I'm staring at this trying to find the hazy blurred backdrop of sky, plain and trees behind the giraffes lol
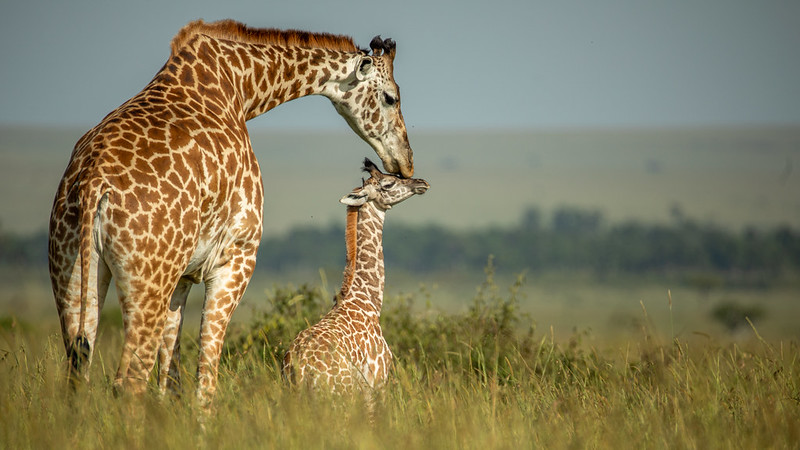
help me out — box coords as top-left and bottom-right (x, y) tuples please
(0, 0), (800, 339)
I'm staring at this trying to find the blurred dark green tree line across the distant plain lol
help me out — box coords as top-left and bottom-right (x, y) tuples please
(0, 207), (800, 275)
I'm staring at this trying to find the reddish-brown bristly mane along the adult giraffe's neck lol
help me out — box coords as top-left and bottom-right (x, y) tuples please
(171, 19), (363, 54)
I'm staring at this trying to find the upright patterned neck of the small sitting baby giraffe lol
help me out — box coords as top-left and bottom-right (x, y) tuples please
(341, 203), (386, 315)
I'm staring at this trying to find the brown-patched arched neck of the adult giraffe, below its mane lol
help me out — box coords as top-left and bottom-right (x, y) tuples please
(167, 30), (357, 120)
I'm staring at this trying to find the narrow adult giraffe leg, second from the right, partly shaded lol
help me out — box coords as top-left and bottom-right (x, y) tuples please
(158, 278), (192, 395)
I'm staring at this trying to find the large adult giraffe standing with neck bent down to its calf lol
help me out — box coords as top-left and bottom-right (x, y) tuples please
(49, 20), (414, 405)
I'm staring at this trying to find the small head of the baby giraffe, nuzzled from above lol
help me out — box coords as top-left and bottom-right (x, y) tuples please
(339, 158), (431, 211)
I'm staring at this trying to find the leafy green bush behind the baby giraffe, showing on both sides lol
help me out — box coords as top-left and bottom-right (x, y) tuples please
(224, 257), (599, 385)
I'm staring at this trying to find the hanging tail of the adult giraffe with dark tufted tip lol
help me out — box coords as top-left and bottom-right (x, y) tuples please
(67, 178), (104, 373)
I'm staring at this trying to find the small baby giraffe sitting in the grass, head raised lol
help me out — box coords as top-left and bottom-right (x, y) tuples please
(283, 159), (430, 392)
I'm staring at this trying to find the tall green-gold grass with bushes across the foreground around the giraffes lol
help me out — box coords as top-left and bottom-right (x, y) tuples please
(0, 264), (800, 449)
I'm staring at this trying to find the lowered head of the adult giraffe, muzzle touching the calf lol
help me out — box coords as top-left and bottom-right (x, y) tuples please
(330, 36), (414, 178)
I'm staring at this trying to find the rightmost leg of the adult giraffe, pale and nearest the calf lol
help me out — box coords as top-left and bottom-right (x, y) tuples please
(197, 245), (258, 409)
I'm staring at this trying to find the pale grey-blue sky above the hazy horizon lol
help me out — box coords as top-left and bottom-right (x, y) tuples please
(0, 0), (800, 132)
